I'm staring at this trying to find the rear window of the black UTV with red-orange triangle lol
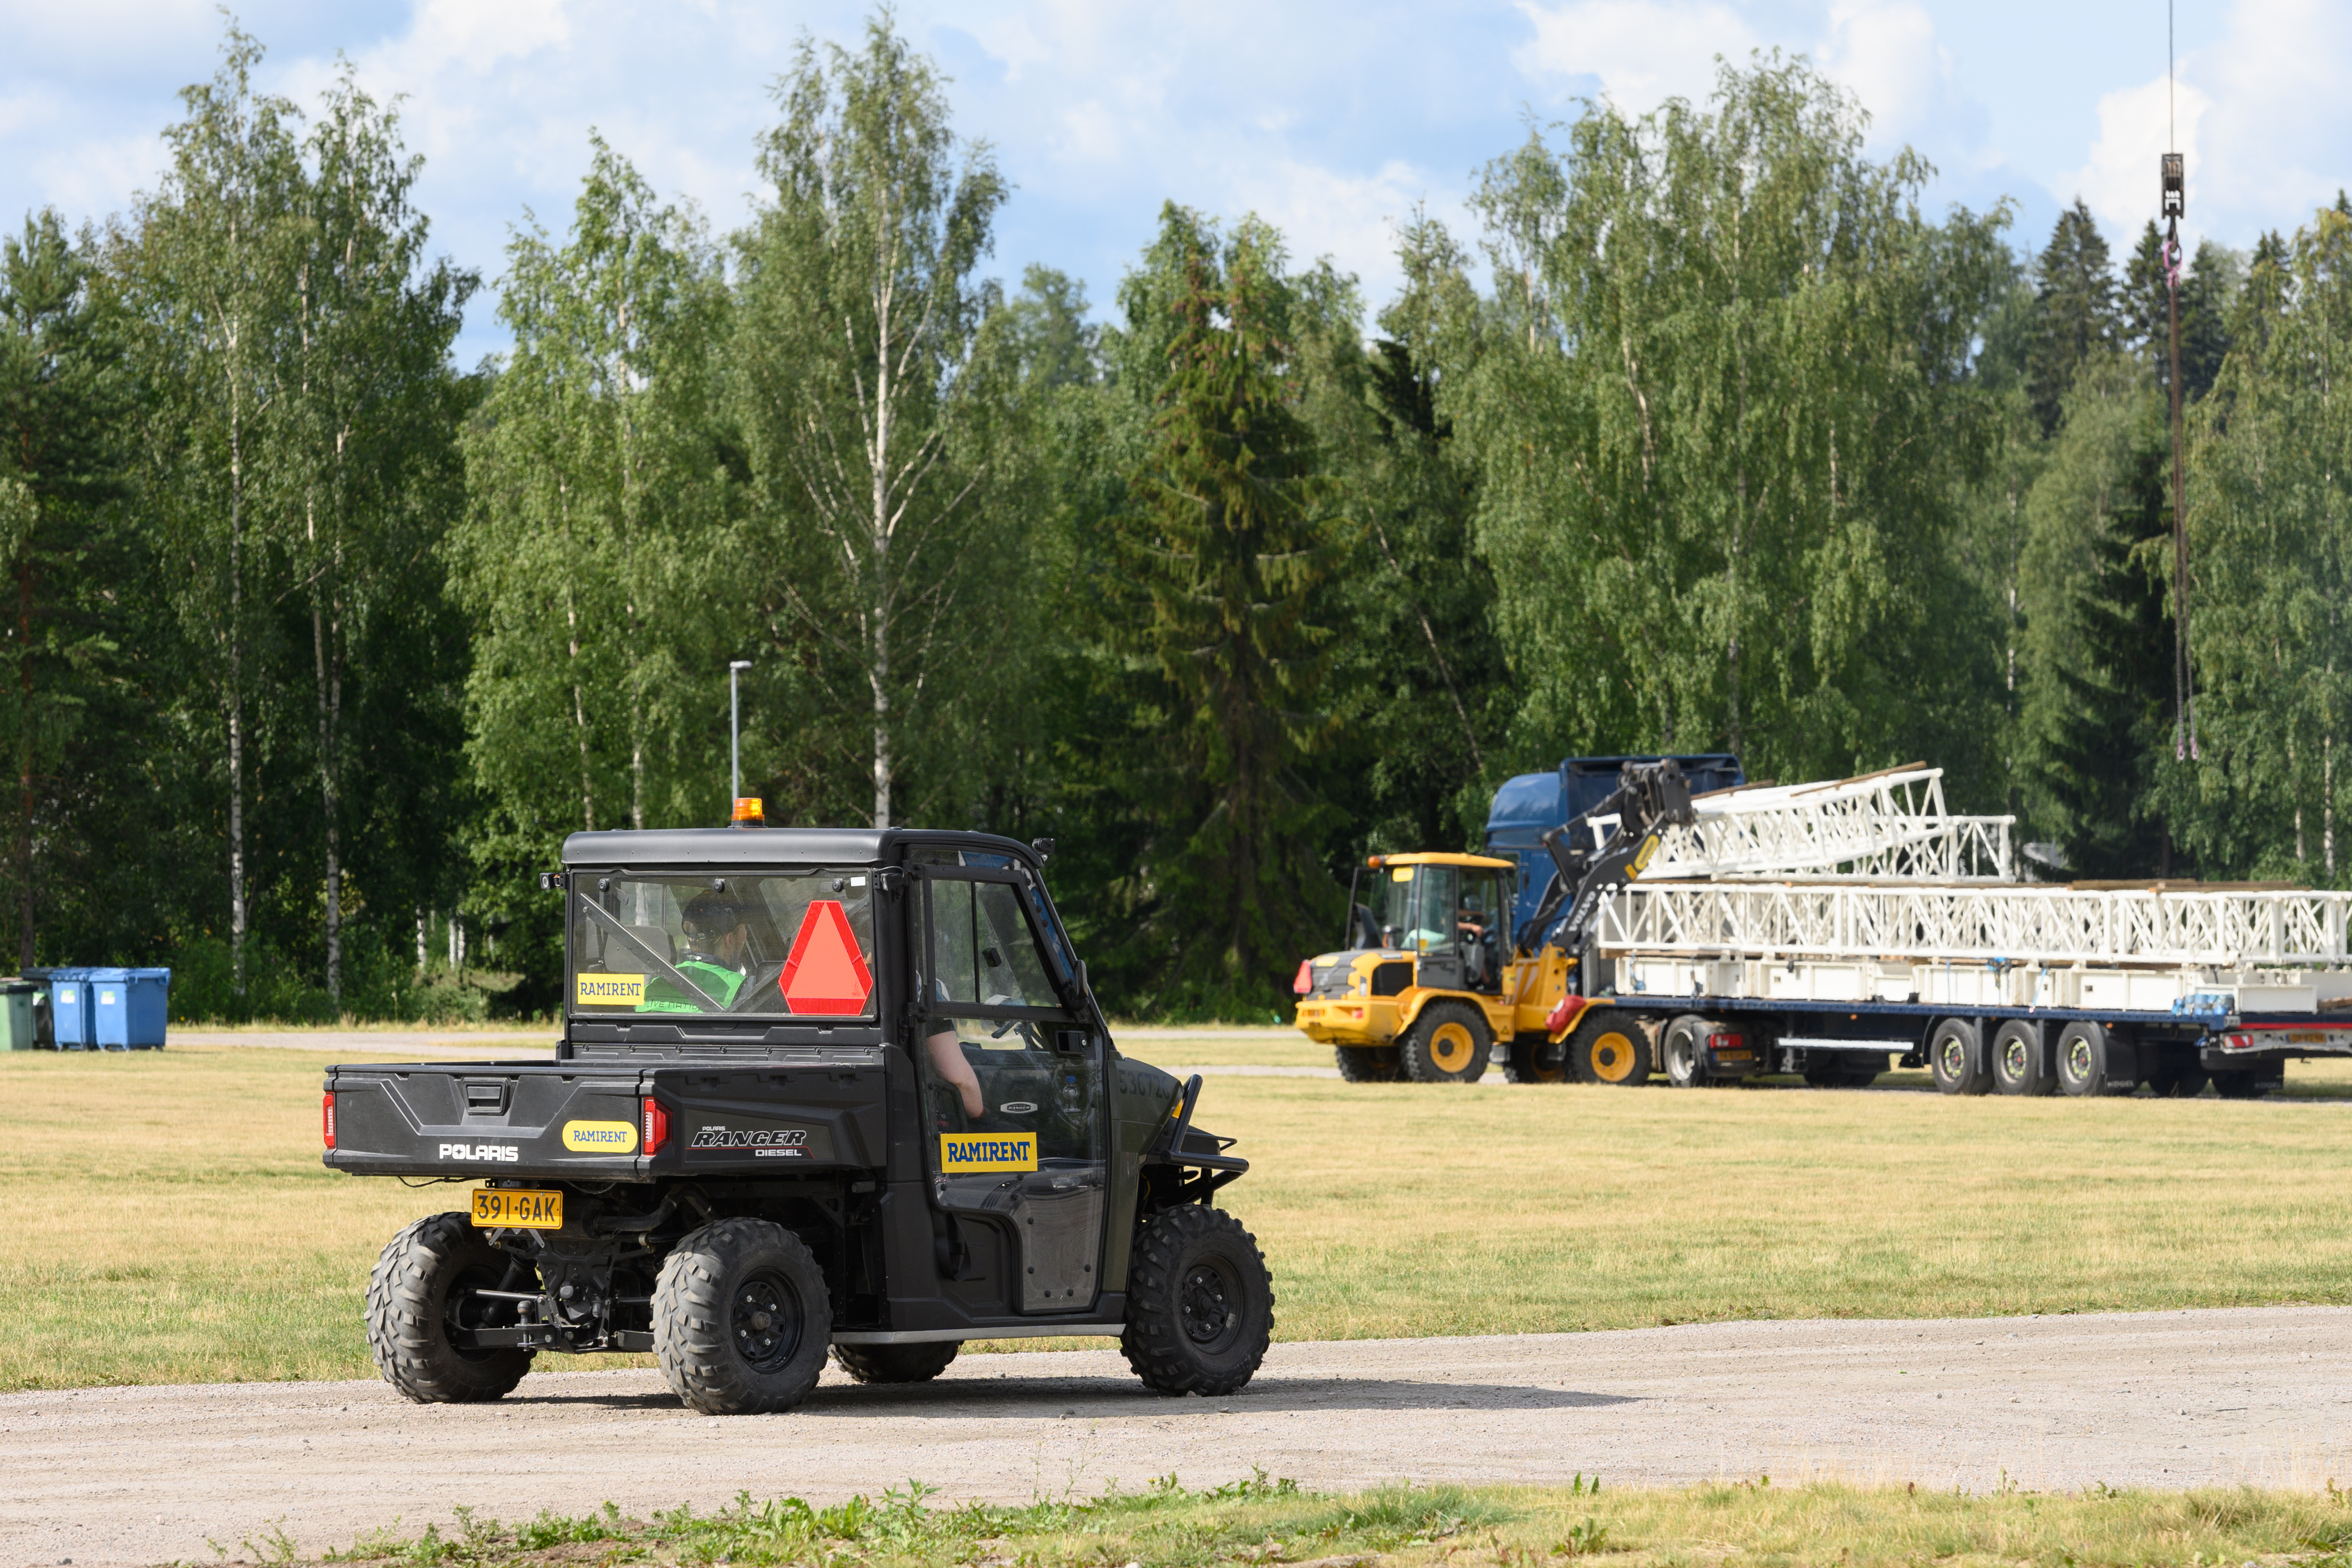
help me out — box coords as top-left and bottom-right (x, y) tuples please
(572, 868), (875, 1020)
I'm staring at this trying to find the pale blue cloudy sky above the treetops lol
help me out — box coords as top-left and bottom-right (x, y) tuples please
(0, 0), (2352, 362)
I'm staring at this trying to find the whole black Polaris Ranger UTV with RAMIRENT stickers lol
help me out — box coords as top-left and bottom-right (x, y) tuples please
(324, 827), (1272, 1415)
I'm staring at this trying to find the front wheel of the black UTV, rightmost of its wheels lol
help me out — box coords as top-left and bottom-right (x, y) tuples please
(1119, 1204), (1275, 1396)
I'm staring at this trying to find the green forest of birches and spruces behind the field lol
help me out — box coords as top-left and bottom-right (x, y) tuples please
(0, 14), (2352, 1020)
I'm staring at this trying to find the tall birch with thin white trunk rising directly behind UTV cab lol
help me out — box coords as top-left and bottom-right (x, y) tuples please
(734, 14), (1007, 827)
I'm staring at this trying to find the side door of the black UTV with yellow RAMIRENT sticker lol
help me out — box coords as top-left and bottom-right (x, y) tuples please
(913, 865), (1110, 1312)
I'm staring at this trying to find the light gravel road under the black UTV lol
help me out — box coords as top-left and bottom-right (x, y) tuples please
(0, 1307), (2352, 1568)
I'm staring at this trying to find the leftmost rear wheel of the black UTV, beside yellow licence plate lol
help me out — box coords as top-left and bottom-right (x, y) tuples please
(367, 1213), (536, 1406)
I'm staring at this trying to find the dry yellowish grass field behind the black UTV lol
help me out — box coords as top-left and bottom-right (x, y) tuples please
(0, 1037), (2352, 1389)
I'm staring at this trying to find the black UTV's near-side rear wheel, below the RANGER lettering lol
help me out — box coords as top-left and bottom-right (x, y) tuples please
(654, 1220), (833, 1415)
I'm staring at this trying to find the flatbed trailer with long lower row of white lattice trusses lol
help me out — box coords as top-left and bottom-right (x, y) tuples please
(1571, 882), (2352, 1098)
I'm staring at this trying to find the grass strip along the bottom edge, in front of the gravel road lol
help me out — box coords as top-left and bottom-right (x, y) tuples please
(298, 1472), (2352, 1568)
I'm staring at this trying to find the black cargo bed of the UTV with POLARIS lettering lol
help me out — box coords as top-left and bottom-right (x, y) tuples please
(324, 1051), (887, 1183)
